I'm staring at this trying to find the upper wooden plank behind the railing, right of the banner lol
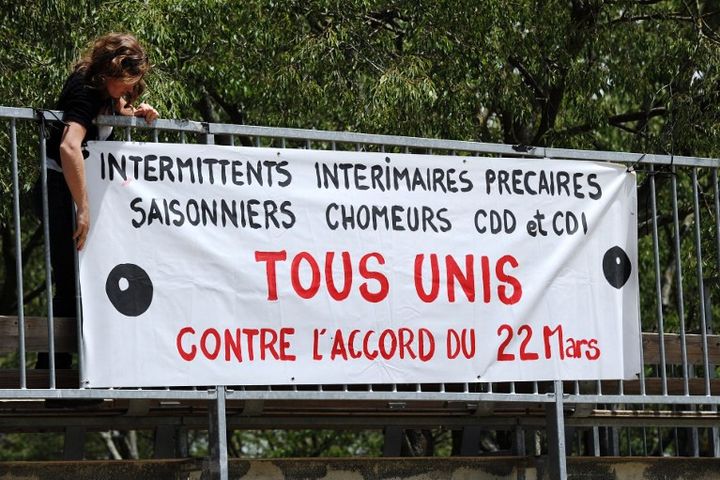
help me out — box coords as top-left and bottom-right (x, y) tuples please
(643, 333), (720, 365)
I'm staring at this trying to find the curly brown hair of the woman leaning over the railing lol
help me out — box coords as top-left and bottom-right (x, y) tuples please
(73, 33), (150, 103)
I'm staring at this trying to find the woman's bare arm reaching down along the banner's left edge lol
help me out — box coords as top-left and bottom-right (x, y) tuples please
(60, 121), (90, 250)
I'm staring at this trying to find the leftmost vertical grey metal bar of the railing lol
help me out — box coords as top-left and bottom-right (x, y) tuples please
(10, 118), (27, 389)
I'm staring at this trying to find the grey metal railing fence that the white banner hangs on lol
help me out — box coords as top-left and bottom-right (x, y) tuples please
(0, 107), (720, 478)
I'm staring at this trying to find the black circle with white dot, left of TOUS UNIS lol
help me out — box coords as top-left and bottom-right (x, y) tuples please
(105, 263), (153, 317)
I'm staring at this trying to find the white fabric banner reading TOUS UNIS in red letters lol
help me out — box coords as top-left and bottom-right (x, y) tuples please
(80, 142), (640, 387)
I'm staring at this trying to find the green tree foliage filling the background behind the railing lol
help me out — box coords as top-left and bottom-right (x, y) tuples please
(0, 0), (720, 460)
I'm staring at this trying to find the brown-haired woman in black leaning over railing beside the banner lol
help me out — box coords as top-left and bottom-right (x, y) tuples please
(36, 33), (158, 368)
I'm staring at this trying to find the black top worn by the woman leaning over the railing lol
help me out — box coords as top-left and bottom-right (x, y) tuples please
(47, 72), (112, 165)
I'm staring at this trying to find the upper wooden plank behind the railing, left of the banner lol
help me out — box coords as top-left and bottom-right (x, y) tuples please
(0, 316), (77, 354)
